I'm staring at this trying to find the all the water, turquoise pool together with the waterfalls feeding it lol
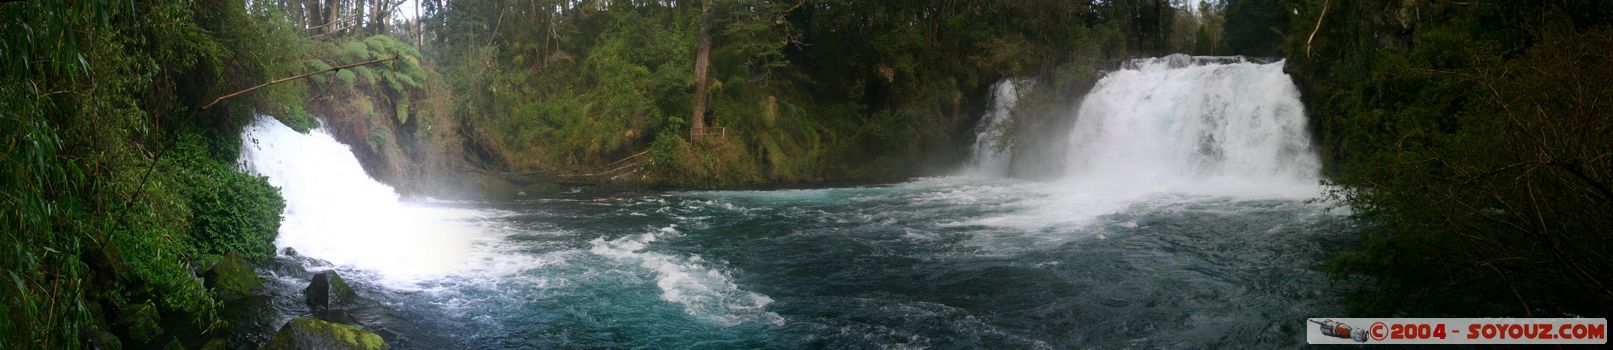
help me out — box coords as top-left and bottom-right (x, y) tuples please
(242, 56), (1353, 348)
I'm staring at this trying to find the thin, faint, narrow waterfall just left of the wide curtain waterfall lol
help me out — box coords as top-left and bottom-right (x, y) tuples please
(971, 79), (1019, 177)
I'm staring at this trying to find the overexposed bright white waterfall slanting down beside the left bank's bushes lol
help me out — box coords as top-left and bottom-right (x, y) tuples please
(240, 116), (471, 279)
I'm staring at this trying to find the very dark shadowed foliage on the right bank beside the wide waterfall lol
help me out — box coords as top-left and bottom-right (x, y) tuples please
(1283, 0), (1613, 316)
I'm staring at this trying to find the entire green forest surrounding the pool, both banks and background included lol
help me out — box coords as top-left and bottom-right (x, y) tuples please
(0, 0), (1613, 348)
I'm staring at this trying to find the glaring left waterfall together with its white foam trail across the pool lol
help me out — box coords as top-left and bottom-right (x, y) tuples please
(240, 116), (782, 326)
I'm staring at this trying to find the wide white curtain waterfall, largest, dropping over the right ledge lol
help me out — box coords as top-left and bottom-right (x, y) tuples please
(1066, 55), (1319, 195)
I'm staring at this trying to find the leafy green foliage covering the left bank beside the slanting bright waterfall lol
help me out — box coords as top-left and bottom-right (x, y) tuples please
(0, 0), (302, 348)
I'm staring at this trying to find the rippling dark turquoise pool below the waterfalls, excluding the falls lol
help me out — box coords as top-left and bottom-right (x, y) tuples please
(235, 177), (1355, 348)
